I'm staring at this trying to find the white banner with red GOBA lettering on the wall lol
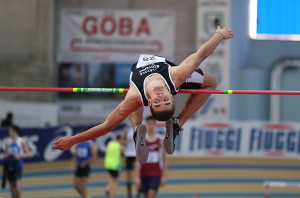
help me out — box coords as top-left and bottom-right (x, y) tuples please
(58, 9), (175, 62)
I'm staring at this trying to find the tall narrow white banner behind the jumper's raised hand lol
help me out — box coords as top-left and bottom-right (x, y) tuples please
(197, 0), (230, 120)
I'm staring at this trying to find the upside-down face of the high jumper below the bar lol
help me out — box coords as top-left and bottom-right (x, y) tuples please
(148, 89), (174, 111)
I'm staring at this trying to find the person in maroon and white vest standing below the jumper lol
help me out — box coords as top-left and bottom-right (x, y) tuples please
(135, 116), (168, 198)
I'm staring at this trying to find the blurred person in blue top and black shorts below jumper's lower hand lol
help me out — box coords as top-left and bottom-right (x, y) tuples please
(70, 130), (97, 198)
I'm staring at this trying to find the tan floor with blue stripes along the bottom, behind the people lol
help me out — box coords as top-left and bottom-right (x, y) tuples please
(0, 157), (300, 198)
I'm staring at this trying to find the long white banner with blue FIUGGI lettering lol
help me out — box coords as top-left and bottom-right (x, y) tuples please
(158, 122), (300, 158)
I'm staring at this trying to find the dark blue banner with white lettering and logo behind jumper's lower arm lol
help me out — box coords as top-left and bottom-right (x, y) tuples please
(0, 124), (125, 162)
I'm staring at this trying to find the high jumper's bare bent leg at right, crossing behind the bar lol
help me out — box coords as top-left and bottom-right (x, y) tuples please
(179, 70), (217, 126)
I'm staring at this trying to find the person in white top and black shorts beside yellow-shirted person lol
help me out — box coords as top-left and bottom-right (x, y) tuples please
(123, 126), (136, 198)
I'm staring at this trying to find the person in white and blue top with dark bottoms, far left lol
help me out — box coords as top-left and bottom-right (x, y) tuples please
(4, 125), (31, 198)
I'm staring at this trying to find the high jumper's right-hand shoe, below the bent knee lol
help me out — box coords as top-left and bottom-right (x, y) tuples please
(164, 117), (183, 155)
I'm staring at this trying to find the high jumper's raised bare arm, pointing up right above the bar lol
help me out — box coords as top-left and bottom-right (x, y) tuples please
(171, 26), (234, 87)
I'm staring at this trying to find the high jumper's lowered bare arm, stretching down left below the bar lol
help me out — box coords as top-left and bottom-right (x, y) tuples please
(53, 88), (143, 151)
